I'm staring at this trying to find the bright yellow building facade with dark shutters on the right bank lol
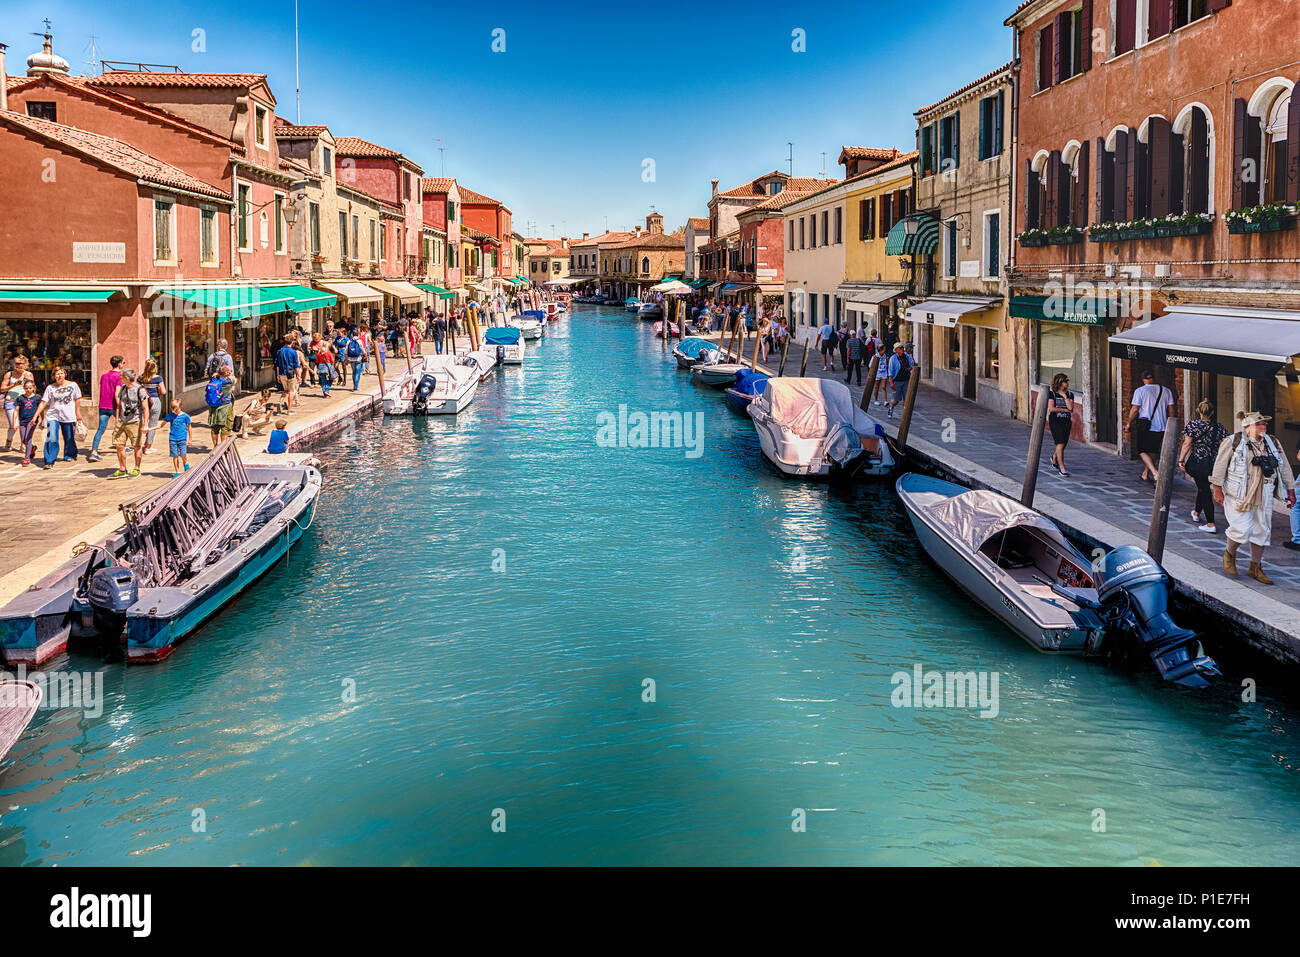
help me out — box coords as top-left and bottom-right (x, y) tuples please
(840, 152), (917, 341)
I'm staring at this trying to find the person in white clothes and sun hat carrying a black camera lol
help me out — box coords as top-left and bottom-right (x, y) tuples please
(1210, 412), (1296, 585)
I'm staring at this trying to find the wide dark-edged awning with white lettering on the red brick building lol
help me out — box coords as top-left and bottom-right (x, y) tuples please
(1110, 304), (1300, 378)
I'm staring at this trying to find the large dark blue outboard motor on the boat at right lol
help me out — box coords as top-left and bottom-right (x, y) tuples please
(1095, 545), (1219, 688)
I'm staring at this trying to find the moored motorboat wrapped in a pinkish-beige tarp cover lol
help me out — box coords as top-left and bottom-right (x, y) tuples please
(748, 377), (894, 480)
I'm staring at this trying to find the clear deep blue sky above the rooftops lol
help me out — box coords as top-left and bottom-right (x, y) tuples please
(0, 0), (1015, 237)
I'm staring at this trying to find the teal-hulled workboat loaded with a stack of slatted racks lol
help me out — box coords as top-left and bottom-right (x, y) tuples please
(0, 442), (321, 667)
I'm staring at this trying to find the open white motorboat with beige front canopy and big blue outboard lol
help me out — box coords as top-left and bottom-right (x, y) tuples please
(897, 473), (1219, 688)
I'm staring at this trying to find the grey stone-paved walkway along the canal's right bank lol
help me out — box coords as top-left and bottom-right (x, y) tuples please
(714, 325), (1300, 607)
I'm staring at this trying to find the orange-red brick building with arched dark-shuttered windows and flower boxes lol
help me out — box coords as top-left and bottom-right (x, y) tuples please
(1006, 0), (1300, 454)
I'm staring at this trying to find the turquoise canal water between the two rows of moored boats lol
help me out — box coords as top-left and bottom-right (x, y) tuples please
(0, 308), (1300, 865)
